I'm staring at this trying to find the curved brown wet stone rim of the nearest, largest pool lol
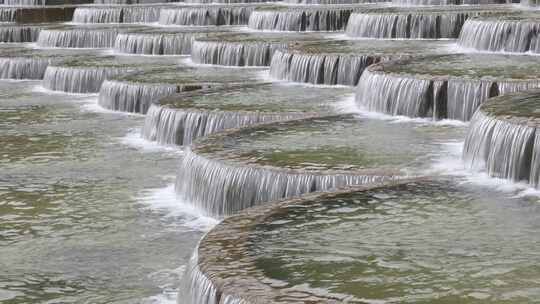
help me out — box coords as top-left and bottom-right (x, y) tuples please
(192, 177), (430, 303)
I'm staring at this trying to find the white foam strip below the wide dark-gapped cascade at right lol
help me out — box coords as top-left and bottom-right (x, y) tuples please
(334, 94), (469, 127)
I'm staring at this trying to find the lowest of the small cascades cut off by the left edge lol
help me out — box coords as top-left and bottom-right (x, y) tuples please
(0, 57), (51, 79)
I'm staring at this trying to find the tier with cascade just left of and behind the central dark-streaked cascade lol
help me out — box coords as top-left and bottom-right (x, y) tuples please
(191, 34), (322, 66)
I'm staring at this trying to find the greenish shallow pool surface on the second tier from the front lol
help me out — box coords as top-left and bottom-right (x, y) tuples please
(194, 112), (461, 171)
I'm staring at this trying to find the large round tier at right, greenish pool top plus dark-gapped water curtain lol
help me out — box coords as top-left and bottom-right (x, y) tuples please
(356, 54), (540, 121)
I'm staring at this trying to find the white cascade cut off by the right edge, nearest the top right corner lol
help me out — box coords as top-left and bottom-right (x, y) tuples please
(458, 19), (540, 53)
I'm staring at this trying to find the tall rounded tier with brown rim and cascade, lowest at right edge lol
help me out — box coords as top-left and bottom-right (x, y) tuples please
(463, 90), (540, 188)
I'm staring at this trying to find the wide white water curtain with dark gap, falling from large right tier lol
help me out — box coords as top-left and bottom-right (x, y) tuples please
(356, 69), (540, 121)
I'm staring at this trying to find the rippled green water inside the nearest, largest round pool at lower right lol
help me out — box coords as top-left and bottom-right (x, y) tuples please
(250, 181), (540, 303)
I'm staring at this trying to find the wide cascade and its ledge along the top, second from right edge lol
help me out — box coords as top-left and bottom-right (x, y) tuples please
(346, 6), (511, 39)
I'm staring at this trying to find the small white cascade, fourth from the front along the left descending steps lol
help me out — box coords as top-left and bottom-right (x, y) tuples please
(99, 80), (182, 114)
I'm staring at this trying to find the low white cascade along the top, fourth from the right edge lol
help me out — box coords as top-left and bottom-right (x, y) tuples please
(159, 5), (255, 26)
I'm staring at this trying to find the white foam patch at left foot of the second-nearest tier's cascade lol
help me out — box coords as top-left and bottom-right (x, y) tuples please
(137, 184), (219, 231)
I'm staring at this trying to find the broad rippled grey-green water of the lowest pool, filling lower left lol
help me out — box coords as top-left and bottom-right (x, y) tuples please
(0, 81), (207, 303)
